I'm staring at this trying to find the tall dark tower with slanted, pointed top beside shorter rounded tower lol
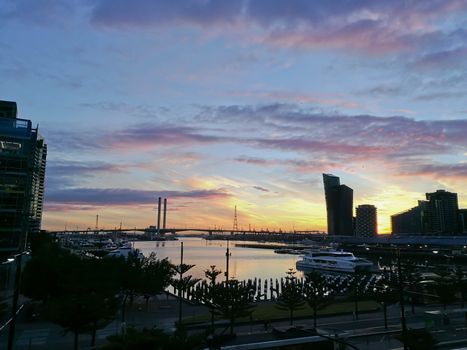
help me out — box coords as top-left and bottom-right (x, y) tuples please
(323, 174), (353, 236)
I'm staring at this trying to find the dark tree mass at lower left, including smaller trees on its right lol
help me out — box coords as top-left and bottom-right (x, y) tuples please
(21, 242), (176, 348)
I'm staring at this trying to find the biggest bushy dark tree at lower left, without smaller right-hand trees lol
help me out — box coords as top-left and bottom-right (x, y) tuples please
(21, 243), (131, 348)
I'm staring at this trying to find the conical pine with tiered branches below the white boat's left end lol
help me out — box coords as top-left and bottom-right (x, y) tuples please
(276, 269), (305, 325)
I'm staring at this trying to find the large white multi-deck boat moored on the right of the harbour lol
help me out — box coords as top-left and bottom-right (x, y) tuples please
(296, 250), (374, 273)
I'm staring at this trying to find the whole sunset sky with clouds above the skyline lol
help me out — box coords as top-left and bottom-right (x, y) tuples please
(0, 0), (467, 233)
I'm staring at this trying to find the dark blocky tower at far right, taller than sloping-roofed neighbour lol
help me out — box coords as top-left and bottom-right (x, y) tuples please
(426, 190), (459, 235)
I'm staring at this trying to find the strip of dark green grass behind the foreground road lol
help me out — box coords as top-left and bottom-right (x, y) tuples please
(183, 300), (379, 325)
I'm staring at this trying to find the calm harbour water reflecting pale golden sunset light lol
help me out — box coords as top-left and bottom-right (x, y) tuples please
(134, 237), (303, 280)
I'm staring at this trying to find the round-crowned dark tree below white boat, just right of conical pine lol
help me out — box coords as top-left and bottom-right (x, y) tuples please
(303, 271), (332, 328)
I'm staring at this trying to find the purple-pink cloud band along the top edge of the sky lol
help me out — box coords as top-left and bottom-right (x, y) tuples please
(91, 0), (467, 54)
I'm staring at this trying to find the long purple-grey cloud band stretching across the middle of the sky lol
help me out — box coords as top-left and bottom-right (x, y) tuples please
(46, 103), (467, 182)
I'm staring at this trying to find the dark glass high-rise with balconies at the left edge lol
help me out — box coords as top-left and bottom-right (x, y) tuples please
(0, 101), (47, 253)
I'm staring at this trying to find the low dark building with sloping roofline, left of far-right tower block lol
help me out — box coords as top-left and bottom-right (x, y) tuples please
(391, 201), (428, 234)
